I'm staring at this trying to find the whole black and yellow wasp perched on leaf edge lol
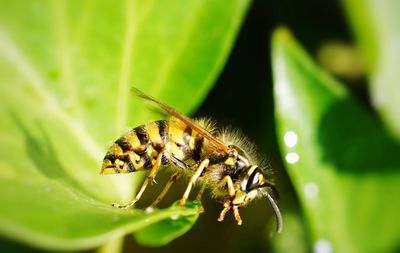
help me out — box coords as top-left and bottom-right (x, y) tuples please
(100, 88), (283, 232)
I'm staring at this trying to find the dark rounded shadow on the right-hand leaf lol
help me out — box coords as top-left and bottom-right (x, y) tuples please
(318, 97), (400, 173)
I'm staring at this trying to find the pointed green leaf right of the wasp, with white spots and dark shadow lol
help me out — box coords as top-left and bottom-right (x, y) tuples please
(272, 29), (400, 252)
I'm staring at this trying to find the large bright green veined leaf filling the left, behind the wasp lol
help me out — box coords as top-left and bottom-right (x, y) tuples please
(0, 0), (249, 249)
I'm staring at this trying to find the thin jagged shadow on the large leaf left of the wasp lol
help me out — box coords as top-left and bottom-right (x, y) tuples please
(10, 111), (90, 195)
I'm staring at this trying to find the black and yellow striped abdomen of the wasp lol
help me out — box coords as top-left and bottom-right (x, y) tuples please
(100, 120), (203, 174)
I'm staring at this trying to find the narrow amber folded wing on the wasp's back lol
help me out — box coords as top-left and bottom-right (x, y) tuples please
(132, 87), (228, 153)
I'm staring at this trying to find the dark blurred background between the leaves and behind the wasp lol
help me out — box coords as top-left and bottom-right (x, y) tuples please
(0, 0), (400, 253)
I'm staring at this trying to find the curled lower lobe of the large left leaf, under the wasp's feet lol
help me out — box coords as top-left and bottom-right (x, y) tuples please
(0, 179), (199, 250)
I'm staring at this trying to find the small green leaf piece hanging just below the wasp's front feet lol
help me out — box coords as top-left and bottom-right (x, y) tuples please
(135, 201), (201, 247)
